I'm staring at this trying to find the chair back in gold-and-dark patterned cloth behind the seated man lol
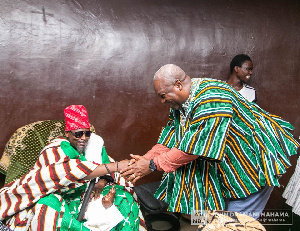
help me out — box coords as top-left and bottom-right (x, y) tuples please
(0, 120), (95, 184)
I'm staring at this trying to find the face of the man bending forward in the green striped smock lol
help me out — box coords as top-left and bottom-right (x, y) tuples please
(153, 80), (188, 110)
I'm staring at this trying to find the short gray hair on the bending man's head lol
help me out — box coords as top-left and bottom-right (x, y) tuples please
(153, 64), (185, 85)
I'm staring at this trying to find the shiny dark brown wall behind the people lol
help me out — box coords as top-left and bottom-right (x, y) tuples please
(0, 0), (300, 227)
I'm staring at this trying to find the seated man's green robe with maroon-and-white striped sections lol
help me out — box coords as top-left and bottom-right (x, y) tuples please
(0, 137), (139, 231)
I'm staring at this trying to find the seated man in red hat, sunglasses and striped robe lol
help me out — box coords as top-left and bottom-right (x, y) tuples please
(0, 105), (144, 231)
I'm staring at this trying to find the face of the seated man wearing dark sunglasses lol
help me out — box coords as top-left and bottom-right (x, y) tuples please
(65, 128), (90, 153)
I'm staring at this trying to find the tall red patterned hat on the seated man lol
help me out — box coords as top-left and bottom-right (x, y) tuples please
(64, 105), (90, 131)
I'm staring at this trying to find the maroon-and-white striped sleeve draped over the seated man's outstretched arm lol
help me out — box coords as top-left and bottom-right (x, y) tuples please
(0, 137), (98, 225)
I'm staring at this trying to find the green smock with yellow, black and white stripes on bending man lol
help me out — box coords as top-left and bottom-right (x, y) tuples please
(155, 79), (299, 214)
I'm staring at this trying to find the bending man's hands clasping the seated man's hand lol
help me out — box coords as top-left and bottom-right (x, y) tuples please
(121, 154), (151, 184)
